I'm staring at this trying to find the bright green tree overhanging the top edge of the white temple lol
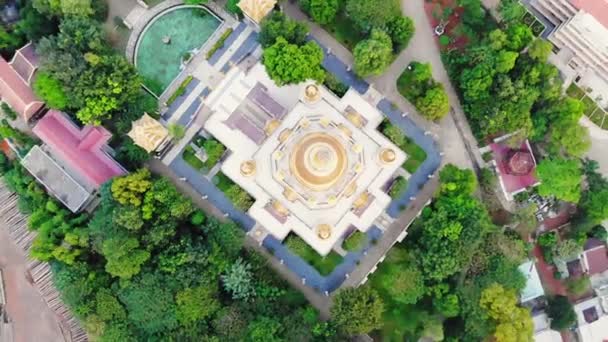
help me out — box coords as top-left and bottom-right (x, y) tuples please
(263, 37), (325, 85)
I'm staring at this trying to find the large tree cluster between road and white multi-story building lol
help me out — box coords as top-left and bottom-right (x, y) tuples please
(444, 19), (590, 157)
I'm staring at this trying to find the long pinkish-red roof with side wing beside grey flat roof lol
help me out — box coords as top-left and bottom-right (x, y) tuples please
(33, 110), (126, 188)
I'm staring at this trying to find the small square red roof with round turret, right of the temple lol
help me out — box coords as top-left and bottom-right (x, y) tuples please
(490, 141), (538, 193)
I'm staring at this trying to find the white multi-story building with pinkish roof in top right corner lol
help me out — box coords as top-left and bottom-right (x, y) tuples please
(528, 0), (608, 108)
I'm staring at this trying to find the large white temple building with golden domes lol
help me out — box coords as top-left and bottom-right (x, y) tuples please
(204, 63), (406, 255)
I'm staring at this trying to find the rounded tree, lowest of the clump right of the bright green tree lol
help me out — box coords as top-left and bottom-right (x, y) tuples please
(353, 29), (393, 77)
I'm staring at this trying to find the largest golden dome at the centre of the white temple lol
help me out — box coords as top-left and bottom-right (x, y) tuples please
(289, 133), (348, 191)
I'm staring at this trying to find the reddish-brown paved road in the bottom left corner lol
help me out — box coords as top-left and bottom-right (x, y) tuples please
(0, 227), (64, 342)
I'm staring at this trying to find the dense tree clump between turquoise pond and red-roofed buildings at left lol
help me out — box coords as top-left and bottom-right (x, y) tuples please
(38, 17), (140, 124)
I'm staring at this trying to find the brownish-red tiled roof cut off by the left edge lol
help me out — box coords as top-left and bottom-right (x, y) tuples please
(0, 44), (44, 121)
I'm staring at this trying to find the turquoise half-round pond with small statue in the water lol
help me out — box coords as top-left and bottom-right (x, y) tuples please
(135, 6), (221, 95)
